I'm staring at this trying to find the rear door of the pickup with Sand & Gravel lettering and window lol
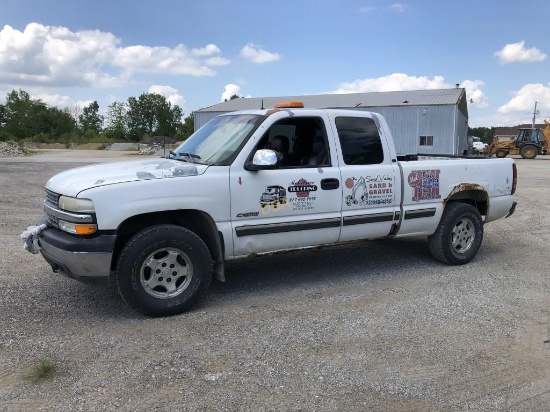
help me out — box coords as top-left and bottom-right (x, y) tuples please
(332, 112), (401, 241)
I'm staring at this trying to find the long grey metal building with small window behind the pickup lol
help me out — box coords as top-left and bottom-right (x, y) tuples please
(194, 87), (468, 155)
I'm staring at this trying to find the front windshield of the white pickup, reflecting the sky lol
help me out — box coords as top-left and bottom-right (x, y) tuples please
(174, 114), (265, 164)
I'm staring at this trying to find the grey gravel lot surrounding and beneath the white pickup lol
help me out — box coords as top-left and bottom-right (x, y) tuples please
(0, 151), (550, 411)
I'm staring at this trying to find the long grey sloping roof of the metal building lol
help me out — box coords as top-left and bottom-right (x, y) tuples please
(197, 87), (468, 118)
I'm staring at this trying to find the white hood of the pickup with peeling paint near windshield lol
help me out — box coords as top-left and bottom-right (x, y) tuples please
(46, 158), (208, 196)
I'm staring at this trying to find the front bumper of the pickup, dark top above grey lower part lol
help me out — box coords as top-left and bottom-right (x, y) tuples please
(38, 217), (116, 283)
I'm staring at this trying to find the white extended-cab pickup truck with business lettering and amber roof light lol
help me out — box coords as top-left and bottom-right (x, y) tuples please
(22, 102), (517, 316)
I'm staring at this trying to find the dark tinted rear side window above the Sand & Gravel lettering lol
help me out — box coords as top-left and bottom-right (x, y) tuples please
(336, 117), (384, 165)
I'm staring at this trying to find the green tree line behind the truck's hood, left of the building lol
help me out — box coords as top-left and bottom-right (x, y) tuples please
(0, 90), (194, 143)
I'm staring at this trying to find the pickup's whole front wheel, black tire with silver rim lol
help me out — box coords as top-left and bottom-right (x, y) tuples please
(115, 225), (212, 316)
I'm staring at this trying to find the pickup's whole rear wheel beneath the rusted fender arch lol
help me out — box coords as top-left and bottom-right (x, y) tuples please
(428, 202), (483, 265)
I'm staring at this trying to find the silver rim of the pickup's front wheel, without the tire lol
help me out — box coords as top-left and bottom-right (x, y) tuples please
(140, 248), (193, 299)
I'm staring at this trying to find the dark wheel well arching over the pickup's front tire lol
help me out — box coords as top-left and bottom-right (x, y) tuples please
(111, 210), (225, 280)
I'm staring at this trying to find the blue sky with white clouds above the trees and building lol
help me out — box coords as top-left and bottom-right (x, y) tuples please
(0, 0), (550, 127)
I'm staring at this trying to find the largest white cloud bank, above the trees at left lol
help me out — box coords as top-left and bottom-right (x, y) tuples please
(0, 23), (229, 87)
